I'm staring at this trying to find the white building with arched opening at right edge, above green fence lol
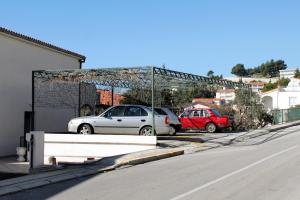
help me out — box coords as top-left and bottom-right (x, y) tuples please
(261, 78), (300, 111)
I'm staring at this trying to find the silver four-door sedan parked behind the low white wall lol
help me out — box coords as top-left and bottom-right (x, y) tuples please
(68, 105), (171, 136)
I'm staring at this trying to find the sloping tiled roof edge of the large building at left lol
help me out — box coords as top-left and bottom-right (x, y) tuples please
(0, 27), (86, 62)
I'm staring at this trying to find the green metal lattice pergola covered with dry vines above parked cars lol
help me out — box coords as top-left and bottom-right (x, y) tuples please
(32, 66), (250, 135)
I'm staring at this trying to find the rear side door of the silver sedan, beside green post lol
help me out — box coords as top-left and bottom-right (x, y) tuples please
(122, 106), (148, 135)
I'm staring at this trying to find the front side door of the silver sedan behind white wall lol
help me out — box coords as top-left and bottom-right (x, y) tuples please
(94, 106), (126, 134)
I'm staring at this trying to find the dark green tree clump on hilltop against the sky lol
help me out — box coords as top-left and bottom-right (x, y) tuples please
(231, 59), (287, 77)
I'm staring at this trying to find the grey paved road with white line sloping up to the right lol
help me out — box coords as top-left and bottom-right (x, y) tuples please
(0, 127), (300, 200)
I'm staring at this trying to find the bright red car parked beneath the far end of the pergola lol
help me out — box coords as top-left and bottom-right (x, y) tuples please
(179, 109), (231, 133)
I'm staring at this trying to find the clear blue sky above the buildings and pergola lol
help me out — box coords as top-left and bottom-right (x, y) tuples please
(0, 0), (300, 76)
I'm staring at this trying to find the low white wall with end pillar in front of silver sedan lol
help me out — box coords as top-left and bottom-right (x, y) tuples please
(26, 131), (157, 168)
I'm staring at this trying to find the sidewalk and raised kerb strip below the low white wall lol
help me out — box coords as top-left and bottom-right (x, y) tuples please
(0, 149), (184, 197)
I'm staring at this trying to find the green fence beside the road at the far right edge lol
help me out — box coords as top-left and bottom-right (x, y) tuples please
(272, 108), (300, 124)
